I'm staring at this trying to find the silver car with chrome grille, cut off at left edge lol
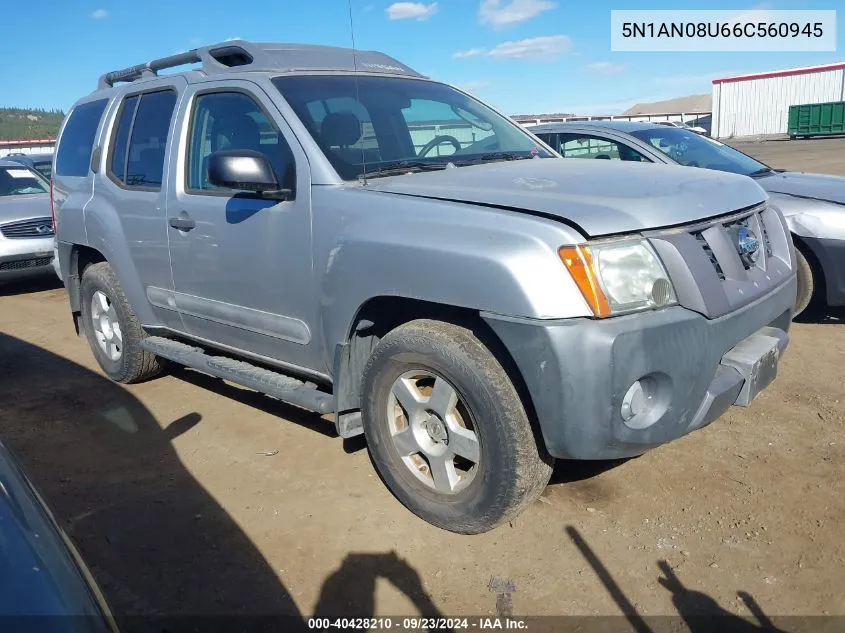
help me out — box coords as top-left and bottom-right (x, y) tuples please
(0, 159), (54, 281)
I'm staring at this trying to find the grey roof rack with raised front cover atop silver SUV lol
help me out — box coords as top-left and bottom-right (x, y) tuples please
(97, 40), (423, 90)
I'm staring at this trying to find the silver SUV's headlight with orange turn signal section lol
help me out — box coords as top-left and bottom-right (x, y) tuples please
(558, 240), (677, 317)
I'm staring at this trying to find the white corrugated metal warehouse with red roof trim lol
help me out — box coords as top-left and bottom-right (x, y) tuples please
(711, 62), (845, 138)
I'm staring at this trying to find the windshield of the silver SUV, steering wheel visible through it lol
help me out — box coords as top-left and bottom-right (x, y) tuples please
(273, 75), (553, 180)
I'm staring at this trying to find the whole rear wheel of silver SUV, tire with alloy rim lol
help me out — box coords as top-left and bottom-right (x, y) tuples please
(81, 262), (164, 383)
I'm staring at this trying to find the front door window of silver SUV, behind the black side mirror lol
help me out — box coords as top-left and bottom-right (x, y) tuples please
(187, 92), (296, 191)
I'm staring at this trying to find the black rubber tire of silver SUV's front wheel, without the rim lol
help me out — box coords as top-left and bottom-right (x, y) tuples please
(362, 319), (554, 534)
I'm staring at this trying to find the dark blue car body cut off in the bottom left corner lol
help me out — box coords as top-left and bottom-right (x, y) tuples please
(0, 442), (117, 633)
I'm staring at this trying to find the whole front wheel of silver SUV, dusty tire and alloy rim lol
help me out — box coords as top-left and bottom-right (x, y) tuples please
(362, 320), (553, 534)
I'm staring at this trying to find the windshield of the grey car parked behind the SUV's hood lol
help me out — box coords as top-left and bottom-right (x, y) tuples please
(631, 127), (770, 176)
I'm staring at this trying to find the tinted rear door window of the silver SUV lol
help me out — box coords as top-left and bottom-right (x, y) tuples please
(109, 90), (176, 190)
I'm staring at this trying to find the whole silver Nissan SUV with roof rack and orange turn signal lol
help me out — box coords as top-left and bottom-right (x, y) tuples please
(53, 41), (796, 533)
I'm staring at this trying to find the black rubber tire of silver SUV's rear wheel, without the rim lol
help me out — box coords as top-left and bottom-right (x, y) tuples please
(80, 262), (164, 383)
